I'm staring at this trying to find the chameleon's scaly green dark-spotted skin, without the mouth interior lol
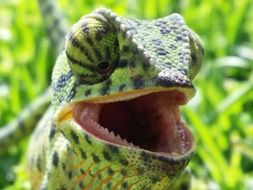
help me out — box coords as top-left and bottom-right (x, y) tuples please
(0, 4), (203, 190)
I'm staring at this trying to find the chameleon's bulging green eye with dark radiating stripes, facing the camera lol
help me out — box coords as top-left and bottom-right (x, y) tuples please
(65, 14), (119, 84)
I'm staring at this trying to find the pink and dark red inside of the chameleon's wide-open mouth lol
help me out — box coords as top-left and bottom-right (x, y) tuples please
(72, 90), (193, 157)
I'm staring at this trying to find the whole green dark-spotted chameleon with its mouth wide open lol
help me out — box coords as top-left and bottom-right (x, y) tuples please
(0, 0), (204, 190)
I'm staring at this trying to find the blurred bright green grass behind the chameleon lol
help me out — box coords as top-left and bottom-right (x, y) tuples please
(0, 0), (253, 189)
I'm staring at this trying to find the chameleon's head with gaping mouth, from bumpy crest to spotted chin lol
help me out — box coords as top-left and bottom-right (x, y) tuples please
(52, 9), (203, 188)
